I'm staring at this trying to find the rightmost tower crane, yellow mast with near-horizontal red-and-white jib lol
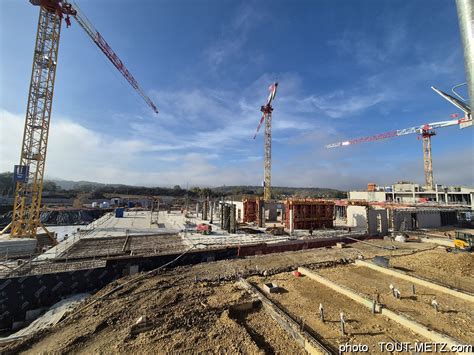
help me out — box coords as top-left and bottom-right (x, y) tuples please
(326, 87), (472, 190)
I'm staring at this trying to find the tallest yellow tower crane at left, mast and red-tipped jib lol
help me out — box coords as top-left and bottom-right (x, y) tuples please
(4, 0), (158, 238)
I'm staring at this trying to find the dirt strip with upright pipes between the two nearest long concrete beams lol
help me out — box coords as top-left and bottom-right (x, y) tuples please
(250, 268), (427, 352)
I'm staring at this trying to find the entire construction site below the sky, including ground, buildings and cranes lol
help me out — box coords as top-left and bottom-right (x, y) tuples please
(0, 0), (474, 354)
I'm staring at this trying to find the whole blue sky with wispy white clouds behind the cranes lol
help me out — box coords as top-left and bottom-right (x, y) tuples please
(0, 0), (474, 189)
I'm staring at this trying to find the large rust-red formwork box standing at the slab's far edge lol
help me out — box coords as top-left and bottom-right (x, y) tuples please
(285, 199), (334, 229)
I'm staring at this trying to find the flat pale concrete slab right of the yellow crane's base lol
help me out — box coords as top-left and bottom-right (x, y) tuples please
(31, 211), (368, 261)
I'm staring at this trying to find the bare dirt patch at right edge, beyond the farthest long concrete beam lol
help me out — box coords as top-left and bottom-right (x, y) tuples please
(390, 247), (474, 293)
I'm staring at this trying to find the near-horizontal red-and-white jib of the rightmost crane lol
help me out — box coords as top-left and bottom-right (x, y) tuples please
(326, 117), (472, 148)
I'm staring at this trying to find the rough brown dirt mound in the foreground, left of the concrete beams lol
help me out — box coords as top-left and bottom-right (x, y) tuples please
(6, 277), (299, 354)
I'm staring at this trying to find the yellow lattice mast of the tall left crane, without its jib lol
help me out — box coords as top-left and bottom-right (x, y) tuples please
(11, 6), (69, 236)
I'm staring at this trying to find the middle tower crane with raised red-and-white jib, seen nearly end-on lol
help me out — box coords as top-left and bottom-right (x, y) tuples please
(253, 82), (278, 201)
